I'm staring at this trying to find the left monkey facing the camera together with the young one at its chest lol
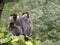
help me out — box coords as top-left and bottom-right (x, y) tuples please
(8, 13), (23, 36)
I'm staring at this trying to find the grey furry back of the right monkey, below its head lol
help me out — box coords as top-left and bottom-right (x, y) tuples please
(21, 18), (31, 36)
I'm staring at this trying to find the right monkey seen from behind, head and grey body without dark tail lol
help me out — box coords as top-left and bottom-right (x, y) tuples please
(22, 12), (31, 36)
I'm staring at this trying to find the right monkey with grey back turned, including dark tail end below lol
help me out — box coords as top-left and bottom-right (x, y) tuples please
(20, 12), (31, 41)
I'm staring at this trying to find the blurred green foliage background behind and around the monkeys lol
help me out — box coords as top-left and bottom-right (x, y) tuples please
(0, 0), (60, 45)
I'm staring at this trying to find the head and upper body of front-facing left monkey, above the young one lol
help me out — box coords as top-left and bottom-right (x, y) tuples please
(8, 13), (20, 25)
